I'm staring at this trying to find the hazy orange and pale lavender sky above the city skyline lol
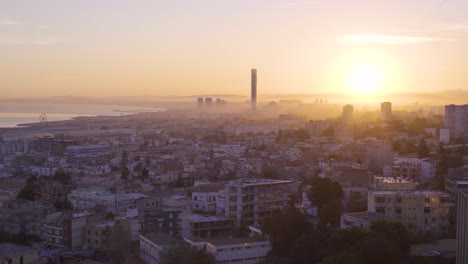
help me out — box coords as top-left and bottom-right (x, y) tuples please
(0, 0), (468, 98)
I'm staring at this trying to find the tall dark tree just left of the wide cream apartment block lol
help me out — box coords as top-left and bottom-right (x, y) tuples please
(308, 177), (343, 225)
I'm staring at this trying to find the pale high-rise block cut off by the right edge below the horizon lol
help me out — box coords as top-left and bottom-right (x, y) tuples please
(445, 104), (468, 138)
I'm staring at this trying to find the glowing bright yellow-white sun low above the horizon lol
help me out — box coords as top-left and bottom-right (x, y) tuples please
(348, 63), (383, 94)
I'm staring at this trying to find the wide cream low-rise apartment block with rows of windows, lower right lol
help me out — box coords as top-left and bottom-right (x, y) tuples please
(367, 191), (452, 232)
